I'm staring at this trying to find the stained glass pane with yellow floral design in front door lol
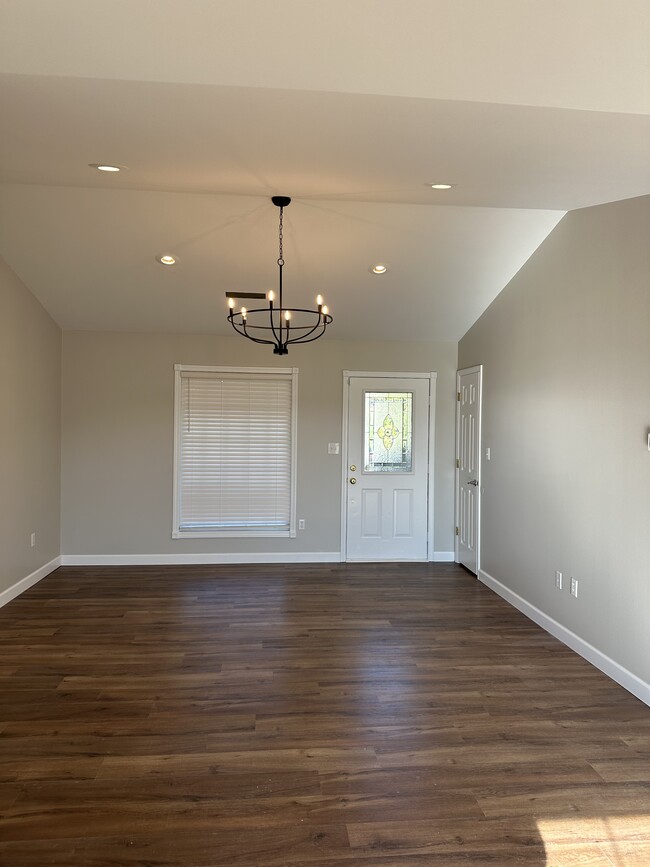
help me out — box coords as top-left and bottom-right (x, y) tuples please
(363, 391), (413, 473)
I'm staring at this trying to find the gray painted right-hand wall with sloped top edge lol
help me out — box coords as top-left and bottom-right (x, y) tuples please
(459, 197), (650, 683)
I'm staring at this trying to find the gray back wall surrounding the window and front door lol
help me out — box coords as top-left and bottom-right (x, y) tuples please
(62, 332), (457, 555)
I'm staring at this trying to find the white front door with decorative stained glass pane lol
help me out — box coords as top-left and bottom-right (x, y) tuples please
(345, 376), (430, 561)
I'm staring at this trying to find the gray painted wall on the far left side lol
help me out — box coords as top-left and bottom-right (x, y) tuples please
(0, 259), (61, 592)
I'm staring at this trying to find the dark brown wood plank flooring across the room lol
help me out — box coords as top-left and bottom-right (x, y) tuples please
(0, 564), (650, 867)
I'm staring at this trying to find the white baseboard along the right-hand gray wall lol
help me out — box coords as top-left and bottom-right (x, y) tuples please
(478, 569), (650, 706)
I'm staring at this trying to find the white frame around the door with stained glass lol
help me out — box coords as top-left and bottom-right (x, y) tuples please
(341, 370), (438, 562)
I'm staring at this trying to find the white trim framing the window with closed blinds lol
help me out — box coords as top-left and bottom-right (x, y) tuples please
(172, 364), (298, 539)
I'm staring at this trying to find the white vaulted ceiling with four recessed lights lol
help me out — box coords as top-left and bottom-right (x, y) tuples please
(0, 0), (650, 340)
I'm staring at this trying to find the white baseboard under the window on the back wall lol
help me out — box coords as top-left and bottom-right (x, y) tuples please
(61, 551), (341, 566)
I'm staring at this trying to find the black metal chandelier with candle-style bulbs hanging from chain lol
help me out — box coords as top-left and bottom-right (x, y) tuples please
(226, 196), (332, 355)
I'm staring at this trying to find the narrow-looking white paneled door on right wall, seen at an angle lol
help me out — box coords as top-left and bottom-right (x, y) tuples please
(456, 367), (482, 575)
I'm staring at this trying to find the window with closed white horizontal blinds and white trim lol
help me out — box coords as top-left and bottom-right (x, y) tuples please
(172, 364), (298, 539)
